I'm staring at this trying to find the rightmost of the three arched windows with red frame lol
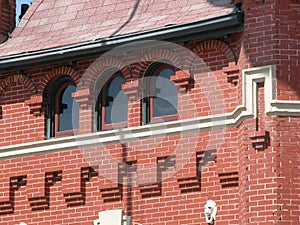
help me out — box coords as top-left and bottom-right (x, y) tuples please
(143, 63), (178, 124)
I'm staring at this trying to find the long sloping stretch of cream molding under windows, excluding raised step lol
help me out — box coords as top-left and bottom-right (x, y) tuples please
(0, 106), (247, 160)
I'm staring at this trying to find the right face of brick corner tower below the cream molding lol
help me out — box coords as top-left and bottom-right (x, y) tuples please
(274, 117), (300, 224)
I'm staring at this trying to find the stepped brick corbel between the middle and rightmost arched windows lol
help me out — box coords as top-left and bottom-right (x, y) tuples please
(121, 79), (144, 101)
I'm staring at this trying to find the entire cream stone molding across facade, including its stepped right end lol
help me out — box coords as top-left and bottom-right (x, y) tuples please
(0, 65), (300, 159)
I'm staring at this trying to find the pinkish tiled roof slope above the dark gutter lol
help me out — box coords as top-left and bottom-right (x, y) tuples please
(0, 0), (233, 56)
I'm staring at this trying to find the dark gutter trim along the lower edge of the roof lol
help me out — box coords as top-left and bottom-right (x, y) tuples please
(0, 11), (244, 72)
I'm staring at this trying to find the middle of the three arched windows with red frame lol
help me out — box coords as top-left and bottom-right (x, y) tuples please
(96, 71), (128, 130)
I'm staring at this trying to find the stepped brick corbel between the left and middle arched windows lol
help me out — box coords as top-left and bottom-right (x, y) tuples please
(72, 88), (95, 109)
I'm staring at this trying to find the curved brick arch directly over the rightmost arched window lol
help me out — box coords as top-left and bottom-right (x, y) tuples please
(138, 49), (184, 77)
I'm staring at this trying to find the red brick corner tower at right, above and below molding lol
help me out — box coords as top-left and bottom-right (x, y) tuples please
(240, 1), (300, 224)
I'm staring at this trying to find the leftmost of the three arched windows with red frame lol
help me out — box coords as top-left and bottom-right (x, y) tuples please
(47, 76), (79, 137)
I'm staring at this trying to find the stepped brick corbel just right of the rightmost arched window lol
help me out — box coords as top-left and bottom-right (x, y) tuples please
(170, 70), (193, 93)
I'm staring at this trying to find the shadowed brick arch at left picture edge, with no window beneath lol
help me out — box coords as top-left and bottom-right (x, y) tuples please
(0, 74), (38, 95)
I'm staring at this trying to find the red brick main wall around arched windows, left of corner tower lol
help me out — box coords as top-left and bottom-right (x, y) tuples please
(0, 37), (238, 224)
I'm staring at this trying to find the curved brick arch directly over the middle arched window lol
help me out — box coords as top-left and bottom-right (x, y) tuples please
(80, 57), (132, 90)
